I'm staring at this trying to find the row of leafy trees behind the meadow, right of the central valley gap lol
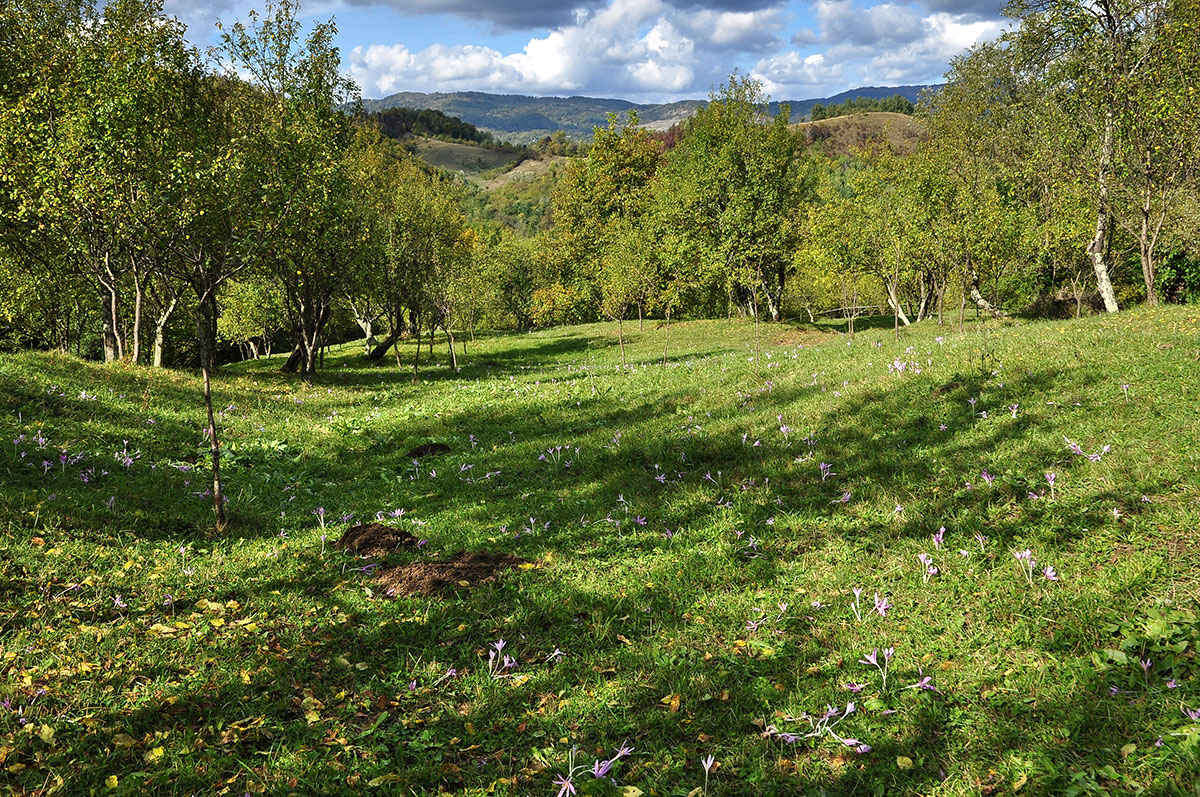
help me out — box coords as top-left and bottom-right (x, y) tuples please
(518, 0), (1200, 338)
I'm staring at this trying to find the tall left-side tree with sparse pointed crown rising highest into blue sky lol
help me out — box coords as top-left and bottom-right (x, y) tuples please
(222, 0), (362, 379)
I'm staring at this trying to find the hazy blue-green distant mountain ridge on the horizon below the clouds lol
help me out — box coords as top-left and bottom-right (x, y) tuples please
(362, 85), (936, 144)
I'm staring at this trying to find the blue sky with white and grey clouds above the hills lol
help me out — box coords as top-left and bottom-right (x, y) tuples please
(166, 0), (1004, 102)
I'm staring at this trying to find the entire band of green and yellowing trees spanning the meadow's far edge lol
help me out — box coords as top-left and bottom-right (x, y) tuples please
(0, 0), (1200, 386)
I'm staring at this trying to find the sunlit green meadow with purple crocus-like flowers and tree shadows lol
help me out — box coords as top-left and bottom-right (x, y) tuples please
(0, 307), (1200, 795)
